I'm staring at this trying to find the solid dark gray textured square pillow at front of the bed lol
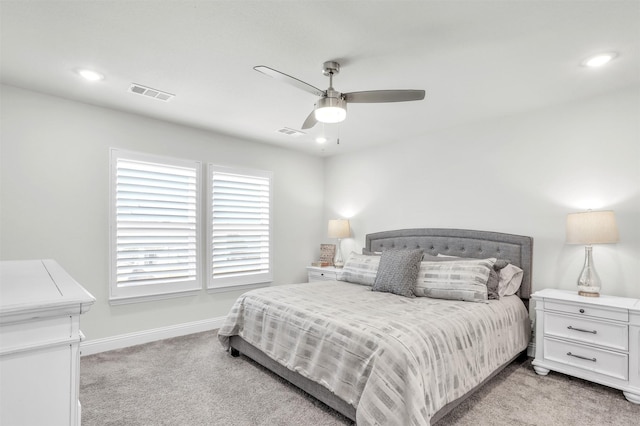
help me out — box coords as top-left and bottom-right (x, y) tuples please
(372, 249), (423, 297)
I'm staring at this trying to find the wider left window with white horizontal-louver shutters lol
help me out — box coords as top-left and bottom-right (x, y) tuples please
(109, 149), (201, 302)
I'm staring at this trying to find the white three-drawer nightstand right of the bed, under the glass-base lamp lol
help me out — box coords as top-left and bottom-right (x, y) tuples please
(531, 289), (640, 404)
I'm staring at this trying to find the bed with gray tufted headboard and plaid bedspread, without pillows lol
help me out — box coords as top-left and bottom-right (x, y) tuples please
(218, 228), (533, 425)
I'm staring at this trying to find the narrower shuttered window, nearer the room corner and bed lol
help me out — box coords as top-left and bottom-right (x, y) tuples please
(207, 164), (273, 288)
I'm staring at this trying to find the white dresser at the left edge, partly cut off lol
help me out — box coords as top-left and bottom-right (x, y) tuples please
(0, 260), (95, 426)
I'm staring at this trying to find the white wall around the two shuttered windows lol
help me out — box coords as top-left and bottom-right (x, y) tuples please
(0, 86), (323, 340)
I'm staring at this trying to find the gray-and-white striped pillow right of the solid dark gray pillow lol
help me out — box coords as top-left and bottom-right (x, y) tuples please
(413, 258), (496, 302)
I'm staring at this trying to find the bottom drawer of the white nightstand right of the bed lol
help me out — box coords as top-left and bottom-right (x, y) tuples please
(544, 338), (629, 380)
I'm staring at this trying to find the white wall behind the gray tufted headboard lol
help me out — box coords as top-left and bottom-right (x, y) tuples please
(324, 86), (640, 297)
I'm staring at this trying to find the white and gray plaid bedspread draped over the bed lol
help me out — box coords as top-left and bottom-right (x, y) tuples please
(218, 281), (529, 426)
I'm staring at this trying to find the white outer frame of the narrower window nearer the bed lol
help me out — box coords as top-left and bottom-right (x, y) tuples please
(205, 164), (273, 291)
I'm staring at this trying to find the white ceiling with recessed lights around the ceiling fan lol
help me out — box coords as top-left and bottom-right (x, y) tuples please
(0, 0), (640, 155)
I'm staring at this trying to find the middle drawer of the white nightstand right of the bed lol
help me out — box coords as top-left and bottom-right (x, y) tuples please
(544, 312), (629, 351)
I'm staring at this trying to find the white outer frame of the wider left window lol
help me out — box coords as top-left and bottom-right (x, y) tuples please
(109, 148), (202, 304)
